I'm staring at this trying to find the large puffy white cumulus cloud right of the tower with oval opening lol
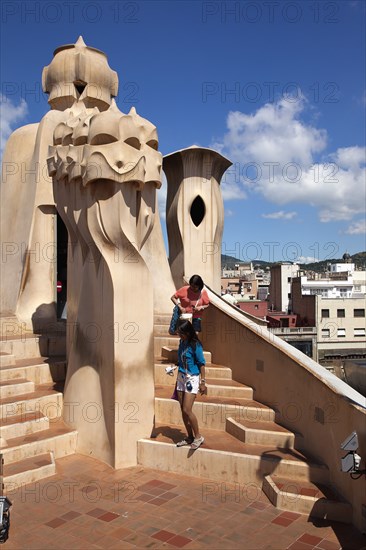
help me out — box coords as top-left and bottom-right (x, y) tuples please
(215, 98), (366, 222)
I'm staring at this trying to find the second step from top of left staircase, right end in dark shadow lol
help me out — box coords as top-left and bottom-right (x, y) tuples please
(0, 357), (66, 384)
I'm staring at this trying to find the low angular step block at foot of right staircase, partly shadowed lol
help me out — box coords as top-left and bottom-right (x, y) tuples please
(263, 472), (352, 523)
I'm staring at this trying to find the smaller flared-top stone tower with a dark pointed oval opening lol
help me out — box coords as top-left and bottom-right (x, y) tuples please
(163, 146), (232, 293)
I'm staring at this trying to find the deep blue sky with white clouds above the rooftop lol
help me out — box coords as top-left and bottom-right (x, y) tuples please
(1, 0), (366, 261)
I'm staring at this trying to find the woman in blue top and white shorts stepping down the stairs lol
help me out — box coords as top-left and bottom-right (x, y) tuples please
(177, 321), (206, 449)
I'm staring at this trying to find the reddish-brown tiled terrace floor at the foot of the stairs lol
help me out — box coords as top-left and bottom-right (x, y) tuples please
(4, 455), (366, 550)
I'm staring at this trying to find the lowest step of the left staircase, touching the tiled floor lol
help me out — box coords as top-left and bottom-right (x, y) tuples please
(3, 452), (56, 496)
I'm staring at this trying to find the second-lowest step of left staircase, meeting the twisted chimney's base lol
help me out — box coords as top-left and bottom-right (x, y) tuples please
(1, 420), (77, 464)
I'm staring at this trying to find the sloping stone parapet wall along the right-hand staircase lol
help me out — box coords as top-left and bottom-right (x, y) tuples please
(202, 286), (366, 529)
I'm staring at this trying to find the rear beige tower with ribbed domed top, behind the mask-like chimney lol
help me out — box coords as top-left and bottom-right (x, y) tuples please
(0, 37), (118, 330)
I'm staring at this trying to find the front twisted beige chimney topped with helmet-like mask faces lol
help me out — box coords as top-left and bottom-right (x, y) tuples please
(48, 97), (162, 467)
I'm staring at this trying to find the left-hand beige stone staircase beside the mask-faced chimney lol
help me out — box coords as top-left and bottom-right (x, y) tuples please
(0, 332), (77, 492)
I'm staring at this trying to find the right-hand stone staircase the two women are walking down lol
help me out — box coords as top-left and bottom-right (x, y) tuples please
(138, 315), (352, 523)
